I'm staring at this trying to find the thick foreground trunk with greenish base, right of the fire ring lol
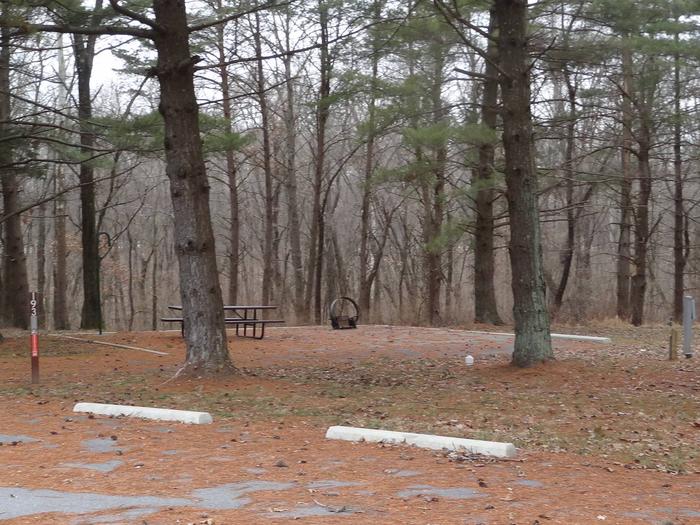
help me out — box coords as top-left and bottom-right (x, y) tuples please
(495, 0), (554, 367)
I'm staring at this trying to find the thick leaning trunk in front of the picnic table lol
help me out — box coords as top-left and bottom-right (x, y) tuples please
(153, 0), (233, 374)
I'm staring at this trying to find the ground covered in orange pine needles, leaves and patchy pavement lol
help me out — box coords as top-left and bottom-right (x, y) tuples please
(0, 326), (700, 525)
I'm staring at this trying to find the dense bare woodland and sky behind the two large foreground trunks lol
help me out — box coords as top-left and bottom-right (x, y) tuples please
(0, 0), (700, 330)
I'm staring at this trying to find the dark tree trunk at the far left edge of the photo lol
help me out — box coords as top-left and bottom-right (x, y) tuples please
(0, 24), (29, 329)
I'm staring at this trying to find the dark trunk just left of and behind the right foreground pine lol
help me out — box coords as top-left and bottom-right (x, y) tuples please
(474, 9), (503, 325)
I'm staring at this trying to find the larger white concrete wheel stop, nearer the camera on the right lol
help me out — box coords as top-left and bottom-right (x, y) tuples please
(326, 426), (516, 458)
